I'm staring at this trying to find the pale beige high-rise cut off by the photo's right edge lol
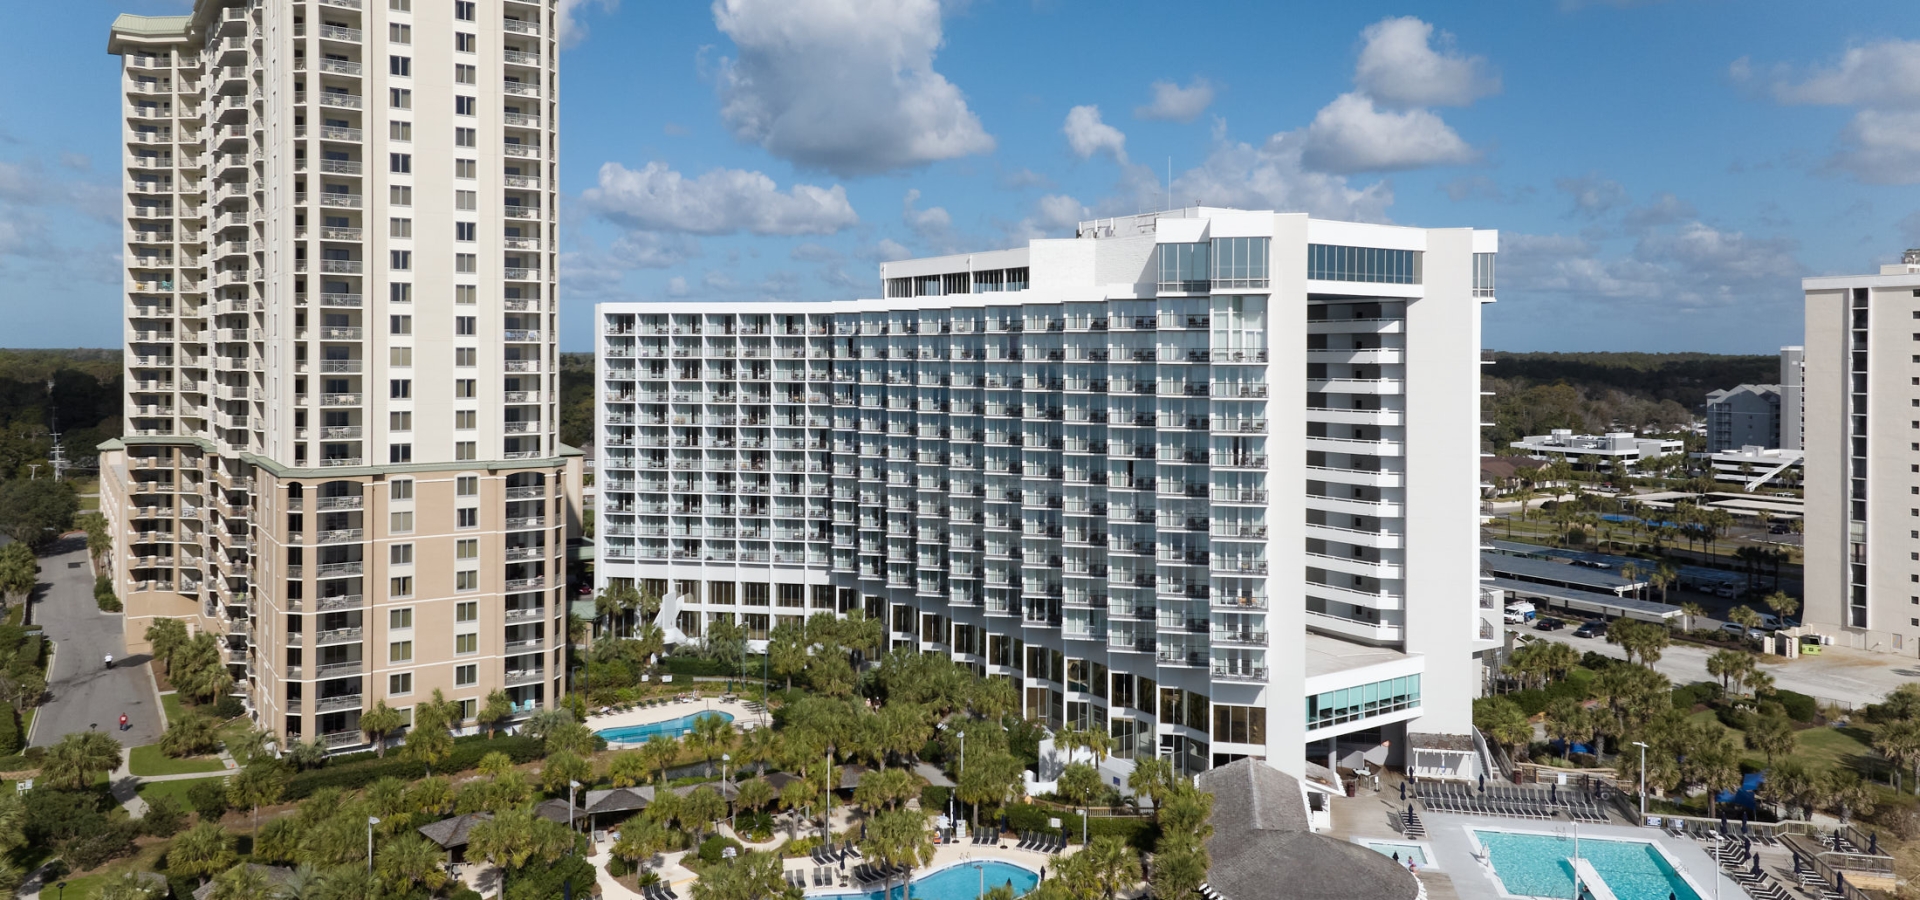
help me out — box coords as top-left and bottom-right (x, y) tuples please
(1803, 249), (1920, 656)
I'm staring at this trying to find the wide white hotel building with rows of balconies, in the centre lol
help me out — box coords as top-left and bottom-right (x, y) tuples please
(595, 209), (1501, 773)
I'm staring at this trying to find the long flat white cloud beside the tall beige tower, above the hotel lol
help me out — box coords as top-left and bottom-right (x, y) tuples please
(582, 161), (860, 234)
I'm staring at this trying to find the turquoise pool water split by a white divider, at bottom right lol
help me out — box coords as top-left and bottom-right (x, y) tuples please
(1473, 831), (1699, 900)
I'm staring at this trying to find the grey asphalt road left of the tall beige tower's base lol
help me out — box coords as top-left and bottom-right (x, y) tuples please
(31, 537), (161, 746)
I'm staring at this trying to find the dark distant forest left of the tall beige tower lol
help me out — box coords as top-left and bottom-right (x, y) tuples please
(0, 349), (123, 480)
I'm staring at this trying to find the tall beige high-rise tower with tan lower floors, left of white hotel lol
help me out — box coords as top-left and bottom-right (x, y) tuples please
(102, 0), (580, 748)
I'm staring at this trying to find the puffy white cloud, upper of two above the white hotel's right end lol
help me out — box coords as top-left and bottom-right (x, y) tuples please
(1354, 15), (1500, 107)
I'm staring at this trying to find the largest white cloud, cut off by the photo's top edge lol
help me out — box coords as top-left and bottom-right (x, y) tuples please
(712, 0), (995, 177)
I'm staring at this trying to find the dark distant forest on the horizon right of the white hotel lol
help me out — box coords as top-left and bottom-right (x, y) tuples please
(1482, 351), (1780, 453)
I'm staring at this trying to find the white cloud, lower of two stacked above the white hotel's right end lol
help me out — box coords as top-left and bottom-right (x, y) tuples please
(1302, 94), (1480, 175)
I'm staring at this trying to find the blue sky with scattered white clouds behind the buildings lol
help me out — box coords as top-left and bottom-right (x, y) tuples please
(0, 0), (1920, 353)
